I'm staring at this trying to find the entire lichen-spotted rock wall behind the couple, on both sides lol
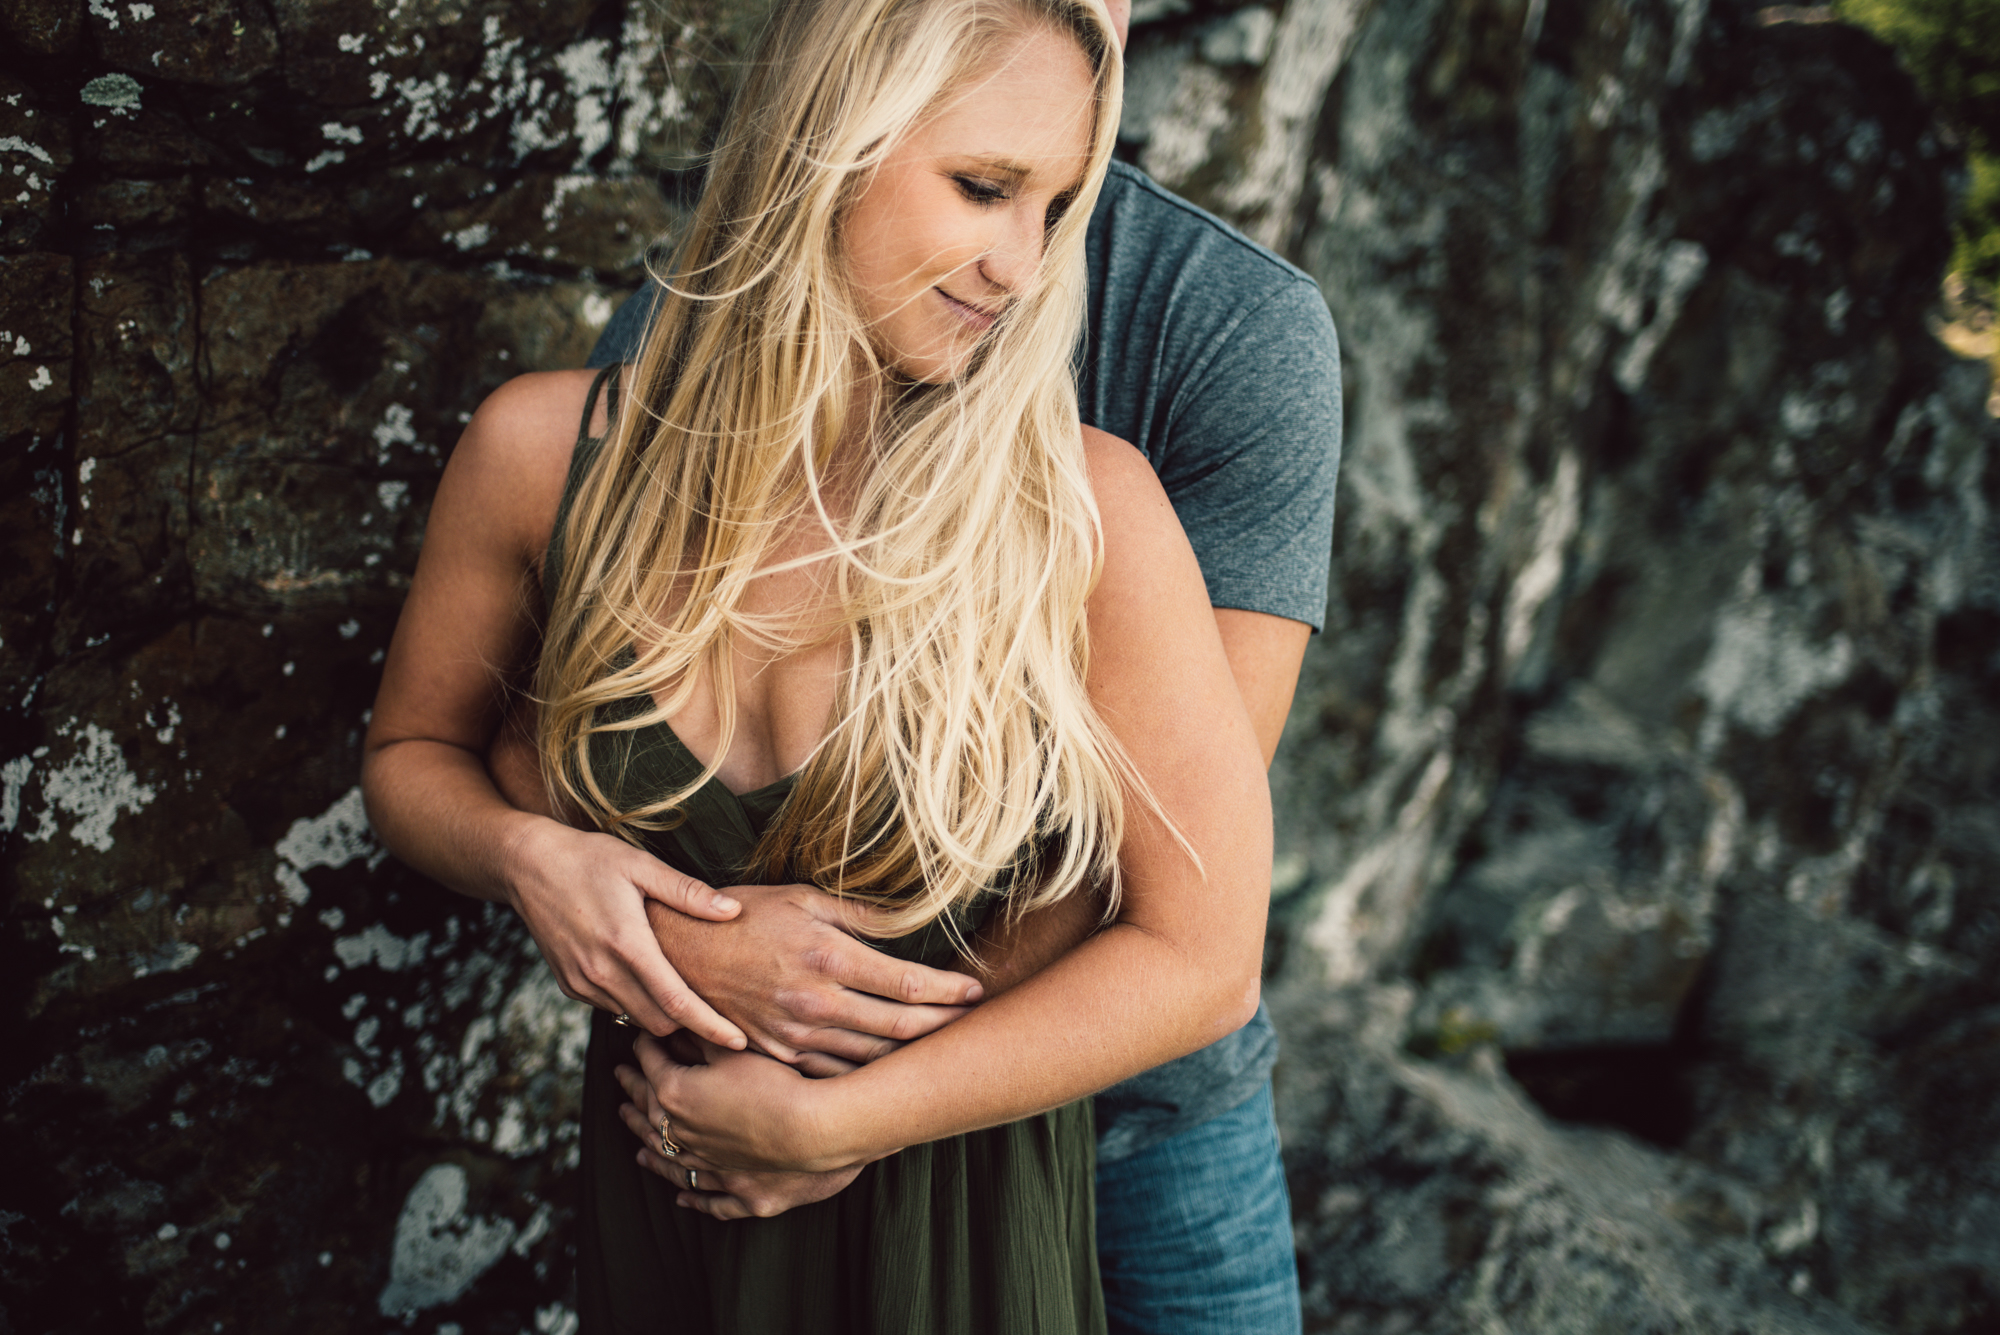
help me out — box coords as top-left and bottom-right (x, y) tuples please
(0, 0), (2000, 1333)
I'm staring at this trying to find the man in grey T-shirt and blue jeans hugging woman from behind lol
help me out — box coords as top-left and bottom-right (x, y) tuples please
(516, 4), (1340, 1335)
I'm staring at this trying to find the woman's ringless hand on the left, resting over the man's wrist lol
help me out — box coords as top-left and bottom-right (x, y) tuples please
(504, 819), (748, 1047)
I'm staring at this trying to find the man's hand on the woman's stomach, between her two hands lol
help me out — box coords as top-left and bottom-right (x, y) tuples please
(646, 885), (986, 1075)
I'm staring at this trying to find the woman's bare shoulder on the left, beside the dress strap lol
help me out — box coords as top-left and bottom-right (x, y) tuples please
(440, 370), (604, 556)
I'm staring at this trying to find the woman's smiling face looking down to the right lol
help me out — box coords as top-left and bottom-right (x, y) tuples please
(842, 24), (1094, 382)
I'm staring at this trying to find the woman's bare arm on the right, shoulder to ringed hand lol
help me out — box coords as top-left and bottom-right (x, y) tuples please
(648, 432), (1270, 1169)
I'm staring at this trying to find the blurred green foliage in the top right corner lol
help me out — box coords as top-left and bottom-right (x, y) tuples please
(1834, 0), (2000, 290)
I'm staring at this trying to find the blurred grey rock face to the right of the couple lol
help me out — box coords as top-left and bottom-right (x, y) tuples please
(1168, 0), (2000, 1331)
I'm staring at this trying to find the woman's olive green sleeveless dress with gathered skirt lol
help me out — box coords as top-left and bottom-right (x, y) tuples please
(544, 365), (1104, 1335)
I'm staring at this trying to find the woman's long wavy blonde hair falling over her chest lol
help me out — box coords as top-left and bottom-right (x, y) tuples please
(536, 0), (1144, 931)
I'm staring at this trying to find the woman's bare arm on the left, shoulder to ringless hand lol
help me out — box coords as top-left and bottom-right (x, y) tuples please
(362, 372), (744, 1047)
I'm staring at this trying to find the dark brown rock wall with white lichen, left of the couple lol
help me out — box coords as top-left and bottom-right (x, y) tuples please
(0, 0), (740, 1331)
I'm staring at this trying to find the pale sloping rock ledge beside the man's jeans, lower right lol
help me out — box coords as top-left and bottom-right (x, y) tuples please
(1280, 987), (1866, 1335)
